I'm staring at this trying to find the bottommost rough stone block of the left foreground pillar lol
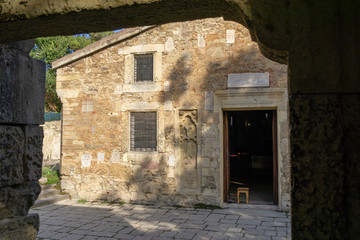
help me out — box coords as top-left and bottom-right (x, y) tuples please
(0, 213), (40, 240)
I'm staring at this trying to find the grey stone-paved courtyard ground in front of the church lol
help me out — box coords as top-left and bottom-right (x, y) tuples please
(31, 200), (291, 240)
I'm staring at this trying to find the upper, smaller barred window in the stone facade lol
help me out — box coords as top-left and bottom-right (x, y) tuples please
(134, 54), (154, 82)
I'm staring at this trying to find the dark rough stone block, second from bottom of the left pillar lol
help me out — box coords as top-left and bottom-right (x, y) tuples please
(0, 181), (41, 219)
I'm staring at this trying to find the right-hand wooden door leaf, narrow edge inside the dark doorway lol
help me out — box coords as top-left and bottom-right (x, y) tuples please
(272, 110), (279, 204)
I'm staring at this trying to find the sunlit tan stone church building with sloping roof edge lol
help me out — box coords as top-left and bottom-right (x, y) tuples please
(53, 18), (290, 210)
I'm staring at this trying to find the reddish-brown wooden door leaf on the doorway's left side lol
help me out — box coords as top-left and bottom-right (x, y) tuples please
(223, 112), (230, 202)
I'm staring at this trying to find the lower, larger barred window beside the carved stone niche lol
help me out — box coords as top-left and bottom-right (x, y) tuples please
(130, 112), (157, 152)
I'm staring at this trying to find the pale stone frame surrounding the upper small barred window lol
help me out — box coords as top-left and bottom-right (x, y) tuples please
(118, 44), (165, 92)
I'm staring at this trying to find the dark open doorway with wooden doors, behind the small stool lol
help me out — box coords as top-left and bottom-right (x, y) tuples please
(224, 110), (278, 204)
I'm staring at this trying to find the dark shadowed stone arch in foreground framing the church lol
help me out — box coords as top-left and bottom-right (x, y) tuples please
(0, 0), (360, 239)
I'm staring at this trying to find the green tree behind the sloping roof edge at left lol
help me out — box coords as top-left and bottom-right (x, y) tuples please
(30, 32), (114, 112)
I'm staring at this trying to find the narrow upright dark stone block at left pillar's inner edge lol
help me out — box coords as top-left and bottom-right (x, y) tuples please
(23, 125), (44, 181)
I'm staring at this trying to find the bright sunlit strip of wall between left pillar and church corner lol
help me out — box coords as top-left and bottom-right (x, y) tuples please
(42, 121), (61, 161)
